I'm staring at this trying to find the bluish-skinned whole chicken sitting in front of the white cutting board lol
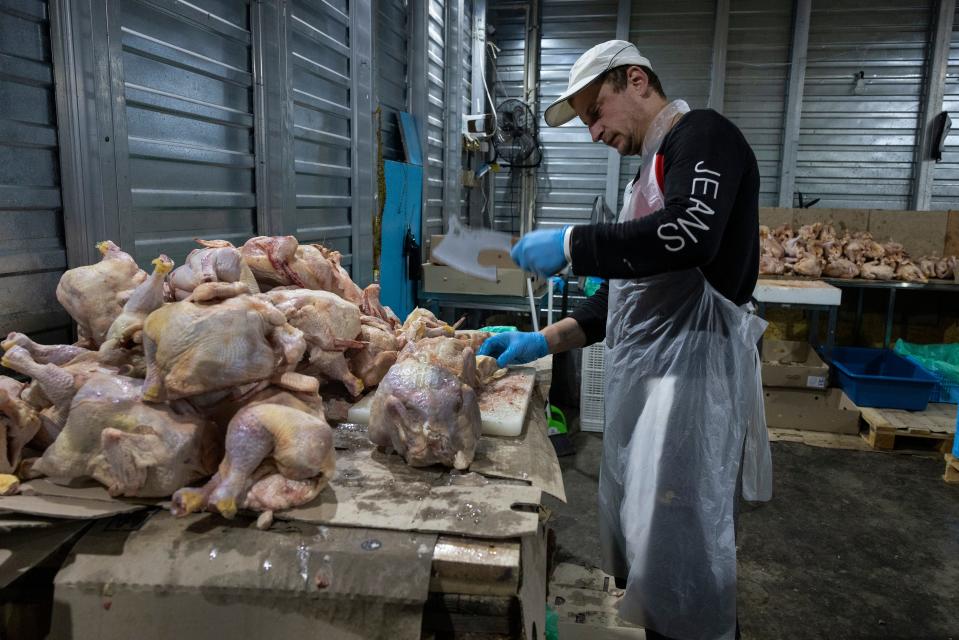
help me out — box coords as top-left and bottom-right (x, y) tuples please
(369, 338), (482, 469)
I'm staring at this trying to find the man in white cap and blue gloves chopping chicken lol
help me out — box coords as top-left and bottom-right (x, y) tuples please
(480, 40), (771, 640)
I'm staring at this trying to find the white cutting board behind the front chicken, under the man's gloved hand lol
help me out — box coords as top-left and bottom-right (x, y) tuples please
(347, 368), (536, 436)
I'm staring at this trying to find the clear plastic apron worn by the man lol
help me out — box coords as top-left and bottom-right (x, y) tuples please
(599, 101), (772, 640)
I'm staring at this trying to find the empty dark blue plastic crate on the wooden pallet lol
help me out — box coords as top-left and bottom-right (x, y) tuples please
(830, 347), (936, 411)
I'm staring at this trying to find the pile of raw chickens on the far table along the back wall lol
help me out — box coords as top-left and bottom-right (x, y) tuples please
(759, 222), (957, 282)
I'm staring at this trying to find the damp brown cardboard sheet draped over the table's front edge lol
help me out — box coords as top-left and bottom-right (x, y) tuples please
(51, 512), (436, 640)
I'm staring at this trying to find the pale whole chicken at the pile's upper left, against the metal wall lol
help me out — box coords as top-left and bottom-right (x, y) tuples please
(57, 240), (147, 349)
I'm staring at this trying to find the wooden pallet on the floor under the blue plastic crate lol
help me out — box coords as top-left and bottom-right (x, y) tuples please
(860, 403), (956, 453)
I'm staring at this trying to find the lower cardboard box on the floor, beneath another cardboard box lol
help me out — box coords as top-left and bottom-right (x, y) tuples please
(763, 387), (859, 434)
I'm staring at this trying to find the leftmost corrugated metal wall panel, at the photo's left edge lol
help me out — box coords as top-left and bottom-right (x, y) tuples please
(0, 0), (70, 341)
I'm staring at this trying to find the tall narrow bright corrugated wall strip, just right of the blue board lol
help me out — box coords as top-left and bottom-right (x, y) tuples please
(423, 0), (446, 235)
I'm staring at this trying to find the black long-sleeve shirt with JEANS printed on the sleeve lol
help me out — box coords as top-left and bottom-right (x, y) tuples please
(570, 109), (759, 344)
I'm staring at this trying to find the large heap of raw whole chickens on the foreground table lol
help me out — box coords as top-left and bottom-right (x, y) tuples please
(0, 236), (502, 517)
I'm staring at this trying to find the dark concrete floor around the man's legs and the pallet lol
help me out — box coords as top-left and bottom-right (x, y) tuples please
(547, 433), (959, 640)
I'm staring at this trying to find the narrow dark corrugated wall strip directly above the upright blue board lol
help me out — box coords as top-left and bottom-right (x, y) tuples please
(373, 0), (409, 161)
